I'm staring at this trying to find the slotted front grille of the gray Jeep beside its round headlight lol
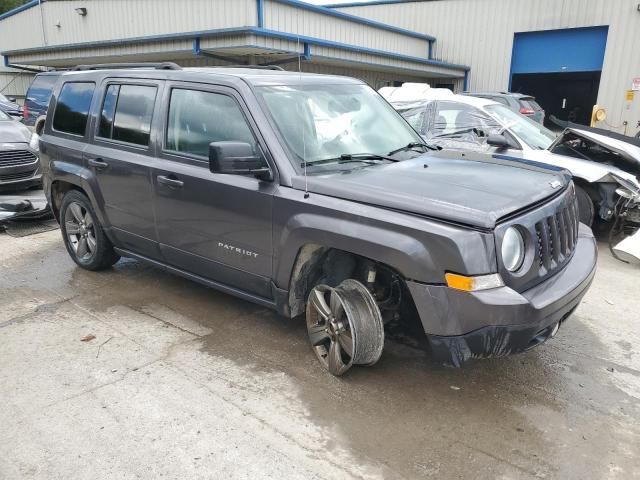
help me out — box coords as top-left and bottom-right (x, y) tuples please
(535, 195), (580, 275)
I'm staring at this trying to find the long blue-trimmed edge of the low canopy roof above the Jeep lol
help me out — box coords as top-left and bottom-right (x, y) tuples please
(2, 27), (469, 70)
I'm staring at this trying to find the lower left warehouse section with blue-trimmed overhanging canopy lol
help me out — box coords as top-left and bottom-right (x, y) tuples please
(0, 0), (468, 96)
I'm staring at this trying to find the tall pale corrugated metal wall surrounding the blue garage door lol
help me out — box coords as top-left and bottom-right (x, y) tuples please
(340, 0), (640, 133)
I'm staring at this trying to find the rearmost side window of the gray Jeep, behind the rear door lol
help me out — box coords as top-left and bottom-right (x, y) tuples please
(53, 82), (96, 135)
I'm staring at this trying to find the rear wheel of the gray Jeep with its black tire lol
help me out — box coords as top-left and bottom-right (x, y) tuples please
(60, 190), (120, 270)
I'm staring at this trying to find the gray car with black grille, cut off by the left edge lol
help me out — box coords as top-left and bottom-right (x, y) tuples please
(0, 111), (42, 190)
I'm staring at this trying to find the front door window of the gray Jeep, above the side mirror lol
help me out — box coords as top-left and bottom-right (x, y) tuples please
(166, 89), (256, 157)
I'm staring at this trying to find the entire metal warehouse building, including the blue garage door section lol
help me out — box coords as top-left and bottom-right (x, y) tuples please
(0, 0), (640, 134)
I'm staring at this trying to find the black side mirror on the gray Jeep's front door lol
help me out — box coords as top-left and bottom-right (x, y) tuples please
(209, 142), (273, 180)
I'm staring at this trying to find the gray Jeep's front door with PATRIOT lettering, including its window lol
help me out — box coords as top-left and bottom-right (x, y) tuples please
(152, 83), (275, 298)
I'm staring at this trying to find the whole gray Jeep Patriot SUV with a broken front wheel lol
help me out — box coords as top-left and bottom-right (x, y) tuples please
(41, 64), (596, 375)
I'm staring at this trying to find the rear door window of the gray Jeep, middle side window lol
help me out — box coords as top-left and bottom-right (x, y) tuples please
(98, 85), (157, 146)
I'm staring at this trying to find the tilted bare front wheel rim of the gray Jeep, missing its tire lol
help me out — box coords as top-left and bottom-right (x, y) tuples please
(306, 279), (384, 376)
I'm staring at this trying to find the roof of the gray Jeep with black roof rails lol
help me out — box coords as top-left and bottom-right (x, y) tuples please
(52, 67), (364, 86)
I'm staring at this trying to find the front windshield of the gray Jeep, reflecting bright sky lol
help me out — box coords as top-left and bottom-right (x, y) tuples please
(258, 85), (421, 168)
